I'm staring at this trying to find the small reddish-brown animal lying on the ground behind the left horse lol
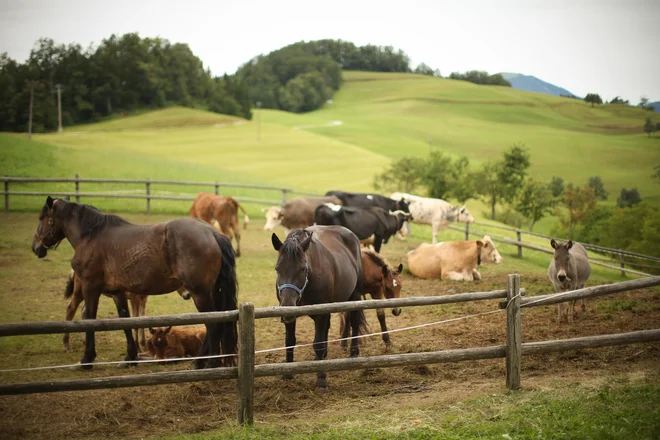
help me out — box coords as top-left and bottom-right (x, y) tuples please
(147, 326), (206, 359)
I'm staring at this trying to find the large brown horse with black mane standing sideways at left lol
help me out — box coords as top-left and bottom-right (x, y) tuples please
(32, 196), (238, 369)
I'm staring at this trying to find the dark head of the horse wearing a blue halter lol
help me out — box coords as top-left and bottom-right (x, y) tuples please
(271, 229), (312, 324)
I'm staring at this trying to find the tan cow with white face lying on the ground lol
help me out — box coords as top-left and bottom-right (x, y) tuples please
(408, 235), (502, 281)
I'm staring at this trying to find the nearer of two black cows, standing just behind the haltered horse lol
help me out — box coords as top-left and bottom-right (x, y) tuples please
(314, 203), (410, 252)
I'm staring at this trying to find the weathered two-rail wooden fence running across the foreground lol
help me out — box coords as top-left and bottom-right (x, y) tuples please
(0, 275), (660, 424)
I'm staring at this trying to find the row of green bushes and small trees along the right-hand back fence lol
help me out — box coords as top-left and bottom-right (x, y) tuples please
(374, 144), (660, 257)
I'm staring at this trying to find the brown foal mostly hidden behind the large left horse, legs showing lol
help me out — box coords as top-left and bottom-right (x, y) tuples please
(62, 269), (190, 352)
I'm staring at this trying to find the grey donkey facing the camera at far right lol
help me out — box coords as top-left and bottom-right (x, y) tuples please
(548, 239), (591, 324)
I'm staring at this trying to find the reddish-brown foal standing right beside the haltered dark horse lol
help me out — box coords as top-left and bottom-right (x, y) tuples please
(339, 248), (403, 348)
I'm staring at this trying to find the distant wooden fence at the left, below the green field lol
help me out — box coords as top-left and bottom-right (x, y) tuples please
(2, 174), (316, 214)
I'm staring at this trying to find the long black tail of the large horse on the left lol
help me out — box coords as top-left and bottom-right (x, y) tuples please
(213, 233), (238, 360)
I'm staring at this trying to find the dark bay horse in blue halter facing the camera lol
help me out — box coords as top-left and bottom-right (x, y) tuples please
(271, 226), (366, 391)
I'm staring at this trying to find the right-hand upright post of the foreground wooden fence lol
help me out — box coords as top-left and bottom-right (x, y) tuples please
(506, 274), (522, 390)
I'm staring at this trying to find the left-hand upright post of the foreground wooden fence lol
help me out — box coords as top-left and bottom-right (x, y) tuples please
(238, 303), (254, 425)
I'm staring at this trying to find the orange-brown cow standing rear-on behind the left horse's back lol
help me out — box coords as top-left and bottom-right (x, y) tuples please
(190, 193), (250, 257)
